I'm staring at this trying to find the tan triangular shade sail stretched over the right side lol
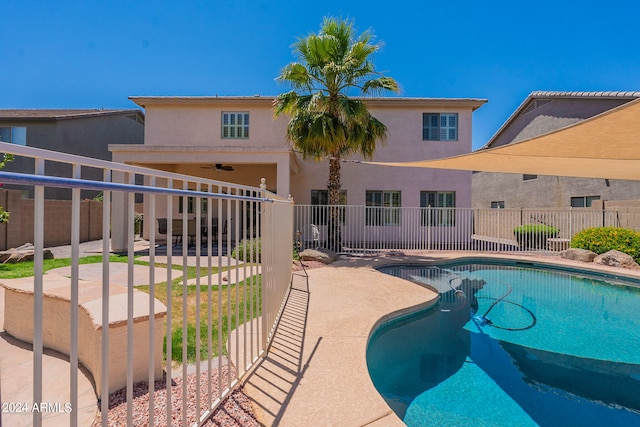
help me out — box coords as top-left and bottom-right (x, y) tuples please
(362, 99), (640, 180)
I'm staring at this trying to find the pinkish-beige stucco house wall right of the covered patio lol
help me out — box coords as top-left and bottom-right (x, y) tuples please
(291, 105), (472, 207)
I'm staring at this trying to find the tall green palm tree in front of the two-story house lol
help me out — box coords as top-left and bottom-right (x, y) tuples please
(274, 18), (398, 251)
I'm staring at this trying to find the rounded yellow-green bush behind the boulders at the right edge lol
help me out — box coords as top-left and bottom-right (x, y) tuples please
(571, 227), (640, 262)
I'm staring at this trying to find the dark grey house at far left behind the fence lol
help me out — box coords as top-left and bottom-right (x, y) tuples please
(0, 109), (144, 199)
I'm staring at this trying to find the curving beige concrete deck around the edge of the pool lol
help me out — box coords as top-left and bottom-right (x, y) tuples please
(244, 252), (640, 427)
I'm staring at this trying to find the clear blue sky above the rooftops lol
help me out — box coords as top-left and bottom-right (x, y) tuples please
(0, 0), (640, 149)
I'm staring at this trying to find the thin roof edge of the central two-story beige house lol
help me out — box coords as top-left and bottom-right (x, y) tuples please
(129, 95), (487, 110)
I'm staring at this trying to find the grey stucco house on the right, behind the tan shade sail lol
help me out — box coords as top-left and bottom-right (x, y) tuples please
(472, 92), (640, 209)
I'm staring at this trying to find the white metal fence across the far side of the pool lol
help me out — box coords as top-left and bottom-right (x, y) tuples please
(294, 205), (619, 253)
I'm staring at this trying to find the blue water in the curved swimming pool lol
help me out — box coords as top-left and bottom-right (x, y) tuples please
(367, 263), (640, 427)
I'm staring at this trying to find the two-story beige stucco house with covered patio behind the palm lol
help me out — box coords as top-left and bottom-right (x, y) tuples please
(110, 96), (486, 242)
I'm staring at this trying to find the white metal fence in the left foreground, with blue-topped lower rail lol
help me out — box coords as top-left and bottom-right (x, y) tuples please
(0, 143), (293, 426)
